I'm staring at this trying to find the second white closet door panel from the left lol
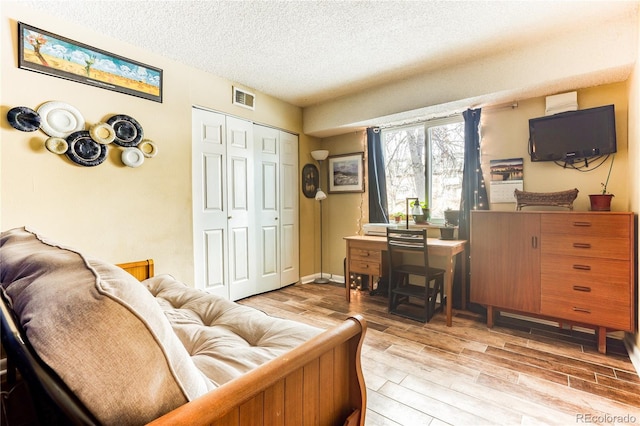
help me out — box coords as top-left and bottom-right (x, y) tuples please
(226, 117), (256, 300)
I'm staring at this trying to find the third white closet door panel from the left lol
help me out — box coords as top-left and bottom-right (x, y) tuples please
(254, 125), (280, 293)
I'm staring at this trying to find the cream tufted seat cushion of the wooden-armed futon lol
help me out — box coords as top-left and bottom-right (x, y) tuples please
(142, 275), (322, 385)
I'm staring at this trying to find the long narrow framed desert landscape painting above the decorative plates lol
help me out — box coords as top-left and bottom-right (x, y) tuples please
(18, 22), (162, 102)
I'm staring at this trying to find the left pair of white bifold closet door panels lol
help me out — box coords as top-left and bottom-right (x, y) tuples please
(192, 108), (256, 300)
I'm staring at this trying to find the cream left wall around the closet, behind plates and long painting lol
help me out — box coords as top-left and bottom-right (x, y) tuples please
(0, 2), (318, 283)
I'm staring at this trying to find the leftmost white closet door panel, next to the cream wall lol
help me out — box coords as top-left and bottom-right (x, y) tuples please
(191, 108), (229, 299)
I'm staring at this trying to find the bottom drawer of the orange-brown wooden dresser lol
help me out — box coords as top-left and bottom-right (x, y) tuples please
(540, 288), (633, 331)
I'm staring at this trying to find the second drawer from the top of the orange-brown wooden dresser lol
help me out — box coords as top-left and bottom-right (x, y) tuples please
(540, 234), (630, 260)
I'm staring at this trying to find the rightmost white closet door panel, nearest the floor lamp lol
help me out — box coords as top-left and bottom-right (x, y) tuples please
(280, 131), (300, 286)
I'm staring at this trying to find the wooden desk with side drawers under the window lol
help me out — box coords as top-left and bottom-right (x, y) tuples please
(345, 235), (467, 327)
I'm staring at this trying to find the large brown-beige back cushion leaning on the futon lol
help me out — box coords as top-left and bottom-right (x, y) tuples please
(0, 228), (215, 424)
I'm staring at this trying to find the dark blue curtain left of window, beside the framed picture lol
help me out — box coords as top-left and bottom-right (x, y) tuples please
(367, 127), (389, 223)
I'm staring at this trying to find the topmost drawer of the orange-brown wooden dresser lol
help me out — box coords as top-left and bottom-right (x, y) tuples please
(540, 213), (631, 239)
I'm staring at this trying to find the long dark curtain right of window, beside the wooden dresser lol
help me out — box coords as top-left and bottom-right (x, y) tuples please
(452, 109), (489, 309)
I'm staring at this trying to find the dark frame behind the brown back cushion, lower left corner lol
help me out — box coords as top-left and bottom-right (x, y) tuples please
(0, 287), (99, 425)
